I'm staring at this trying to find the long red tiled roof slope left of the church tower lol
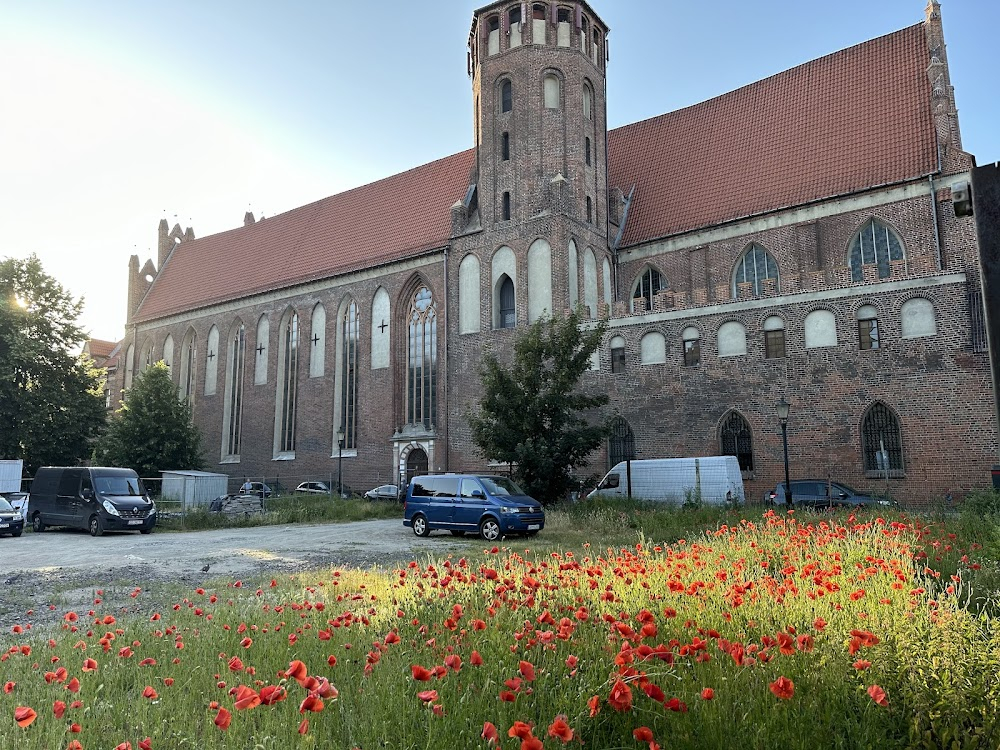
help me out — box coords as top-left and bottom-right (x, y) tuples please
(136, 149), (475, 320)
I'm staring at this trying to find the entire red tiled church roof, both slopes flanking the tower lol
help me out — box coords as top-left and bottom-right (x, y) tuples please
(136, 24), (937, 321)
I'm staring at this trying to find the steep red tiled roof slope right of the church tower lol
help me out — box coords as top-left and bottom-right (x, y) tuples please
(609, 24), (937, 246)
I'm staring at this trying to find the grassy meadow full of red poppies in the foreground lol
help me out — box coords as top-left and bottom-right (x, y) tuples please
(0, 511), (1000, 750)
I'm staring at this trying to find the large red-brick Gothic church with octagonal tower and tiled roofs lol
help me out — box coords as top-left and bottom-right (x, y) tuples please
(116, 0), (997, 502)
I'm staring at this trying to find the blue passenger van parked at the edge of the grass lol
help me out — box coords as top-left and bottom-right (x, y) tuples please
(403, 474), (545, 542)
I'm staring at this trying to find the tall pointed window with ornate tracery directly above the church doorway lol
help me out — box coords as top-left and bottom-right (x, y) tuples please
(406, 287), (437, 429)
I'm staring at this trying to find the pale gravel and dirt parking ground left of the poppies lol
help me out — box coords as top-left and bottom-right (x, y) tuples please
(0, 519), (466, 643)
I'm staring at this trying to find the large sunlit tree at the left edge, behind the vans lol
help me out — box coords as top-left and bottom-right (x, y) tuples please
(0, 255), (105, 473)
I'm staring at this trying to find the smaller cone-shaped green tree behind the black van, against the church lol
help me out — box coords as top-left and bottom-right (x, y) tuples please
(94, 362), (202, 477)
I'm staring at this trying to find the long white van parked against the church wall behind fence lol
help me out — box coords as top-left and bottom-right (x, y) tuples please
(588, 456), (746, 505)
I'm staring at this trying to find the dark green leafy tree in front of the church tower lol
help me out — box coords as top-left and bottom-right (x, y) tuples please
(469, 311), (608, 502)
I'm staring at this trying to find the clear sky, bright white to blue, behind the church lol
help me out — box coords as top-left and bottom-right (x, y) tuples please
(0, 0), (1000, 339)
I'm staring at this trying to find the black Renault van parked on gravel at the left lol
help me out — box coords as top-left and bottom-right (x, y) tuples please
(28, 466), (156, 536)
